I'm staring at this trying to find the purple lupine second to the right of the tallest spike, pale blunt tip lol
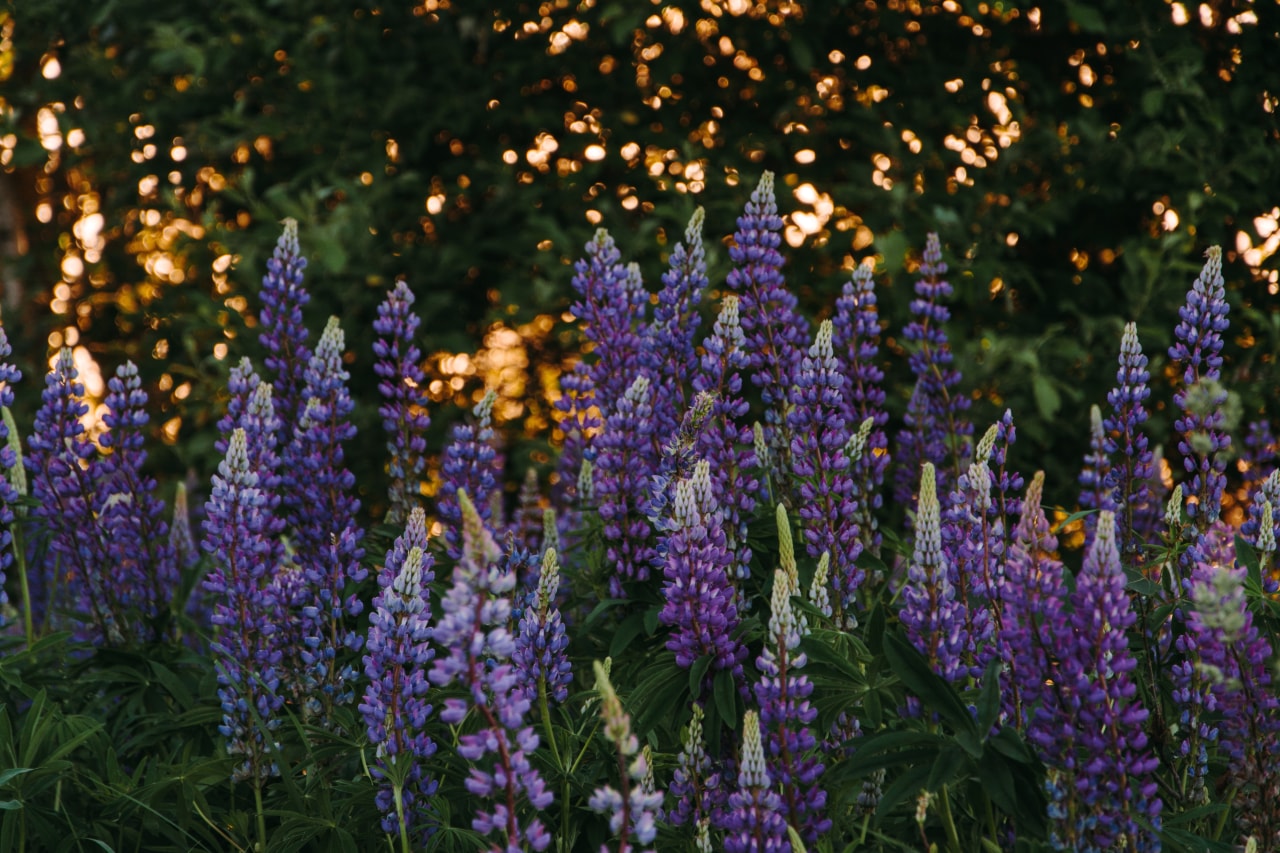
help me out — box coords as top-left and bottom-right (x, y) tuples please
(832, 258), (890, 555)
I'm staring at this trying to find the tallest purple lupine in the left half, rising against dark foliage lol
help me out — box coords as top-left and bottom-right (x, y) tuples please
(257, 219), (311, 435)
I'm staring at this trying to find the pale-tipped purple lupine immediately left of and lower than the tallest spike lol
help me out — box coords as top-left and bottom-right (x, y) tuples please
(692, 295), (760, 580)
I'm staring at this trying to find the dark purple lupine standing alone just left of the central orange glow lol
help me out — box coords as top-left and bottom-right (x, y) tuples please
(374, 279), (431, 524)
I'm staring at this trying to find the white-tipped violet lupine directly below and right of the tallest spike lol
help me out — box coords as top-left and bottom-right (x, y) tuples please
(787, 320), (864, 626)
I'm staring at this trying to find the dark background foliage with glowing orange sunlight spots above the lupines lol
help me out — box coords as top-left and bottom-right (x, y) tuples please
(0, 0), (1280, 514)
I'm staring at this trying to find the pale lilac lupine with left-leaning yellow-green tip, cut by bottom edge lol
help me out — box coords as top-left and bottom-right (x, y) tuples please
(588, 661), (662, 853)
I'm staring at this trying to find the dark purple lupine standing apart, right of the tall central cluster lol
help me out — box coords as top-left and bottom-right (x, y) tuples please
(893, 232), (973, 505)
